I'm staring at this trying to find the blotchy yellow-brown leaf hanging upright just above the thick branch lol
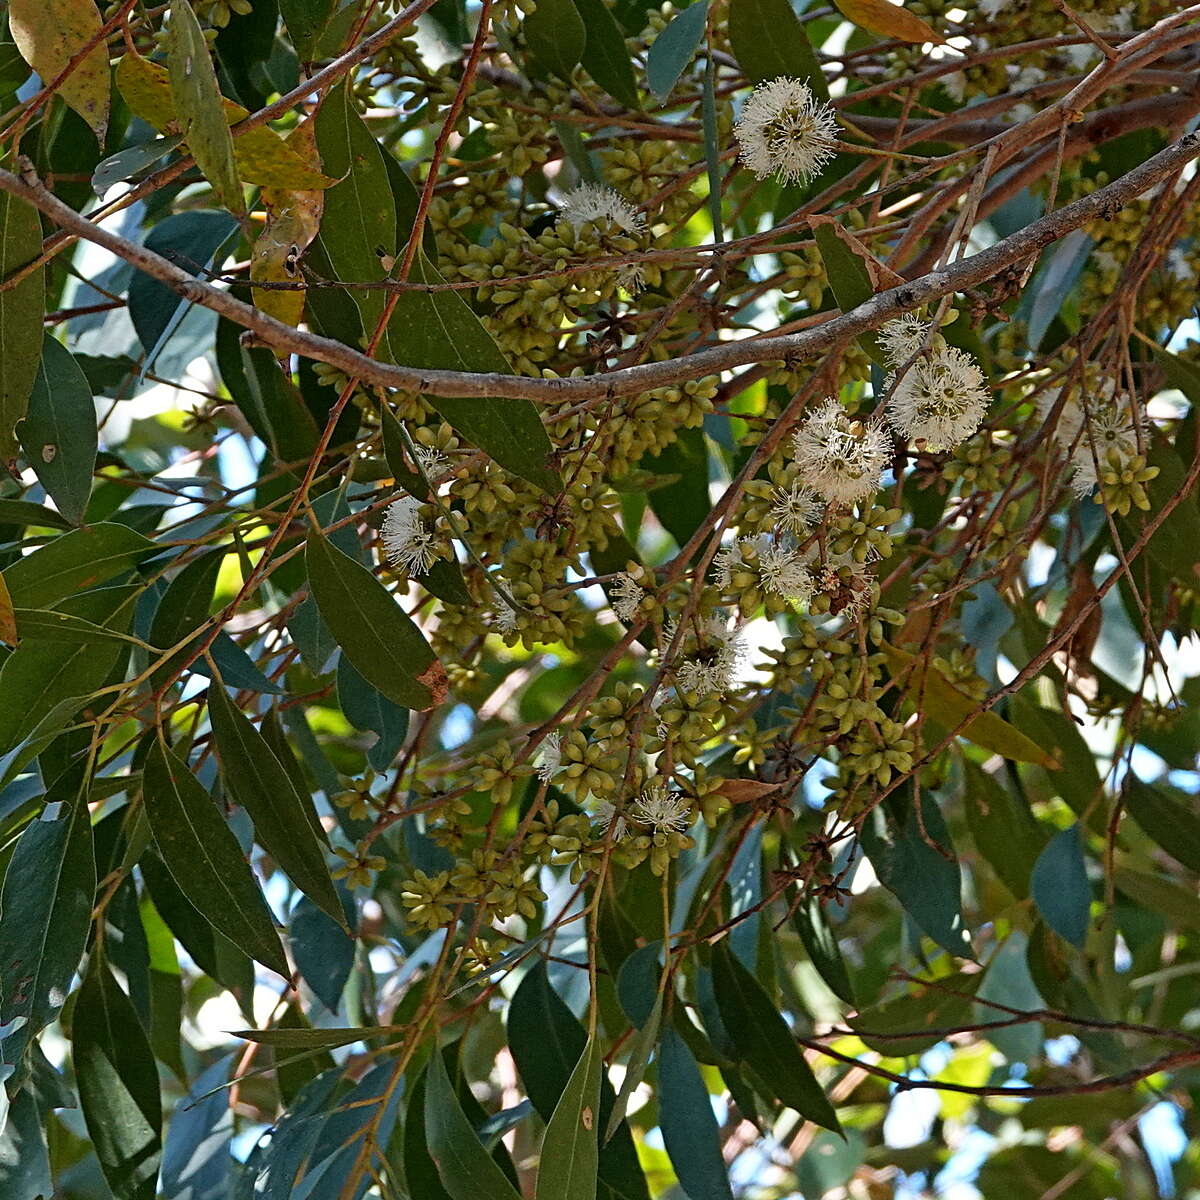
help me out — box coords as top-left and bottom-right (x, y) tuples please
(250, 121), (325, 325)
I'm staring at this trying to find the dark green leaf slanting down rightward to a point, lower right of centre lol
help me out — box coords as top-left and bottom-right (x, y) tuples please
(713, 942), (841, 1133)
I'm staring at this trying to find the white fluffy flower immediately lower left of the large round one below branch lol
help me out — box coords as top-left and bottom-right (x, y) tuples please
(792, 398), (892, 504)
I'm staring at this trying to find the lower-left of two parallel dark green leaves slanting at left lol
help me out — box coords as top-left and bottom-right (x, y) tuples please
(142, 740), (288, 978)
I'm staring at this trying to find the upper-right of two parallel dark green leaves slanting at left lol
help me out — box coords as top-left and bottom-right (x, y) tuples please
(209, 684), (346, 928)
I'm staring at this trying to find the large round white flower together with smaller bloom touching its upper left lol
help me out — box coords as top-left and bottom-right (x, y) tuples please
(880, 313), (991, 454)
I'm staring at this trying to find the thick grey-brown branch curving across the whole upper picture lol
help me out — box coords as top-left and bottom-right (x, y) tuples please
(0, 133), (1200, 402)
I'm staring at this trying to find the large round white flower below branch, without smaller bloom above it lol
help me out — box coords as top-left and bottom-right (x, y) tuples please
(887, 346), (991, 452)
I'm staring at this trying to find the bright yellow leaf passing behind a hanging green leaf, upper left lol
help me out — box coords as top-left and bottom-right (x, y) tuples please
(116, 50), (337, 190)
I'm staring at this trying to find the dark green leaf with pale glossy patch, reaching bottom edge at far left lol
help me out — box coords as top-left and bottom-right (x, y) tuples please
(72, 953), (162, 1200)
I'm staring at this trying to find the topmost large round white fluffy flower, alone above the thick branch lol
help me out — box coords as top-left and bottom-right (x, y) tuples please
(733, 76), (838, 184)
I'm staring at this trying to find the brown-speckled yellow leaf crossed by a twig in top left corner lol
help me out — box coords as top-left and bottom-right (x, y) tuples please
(8, 0), (109, 145)
